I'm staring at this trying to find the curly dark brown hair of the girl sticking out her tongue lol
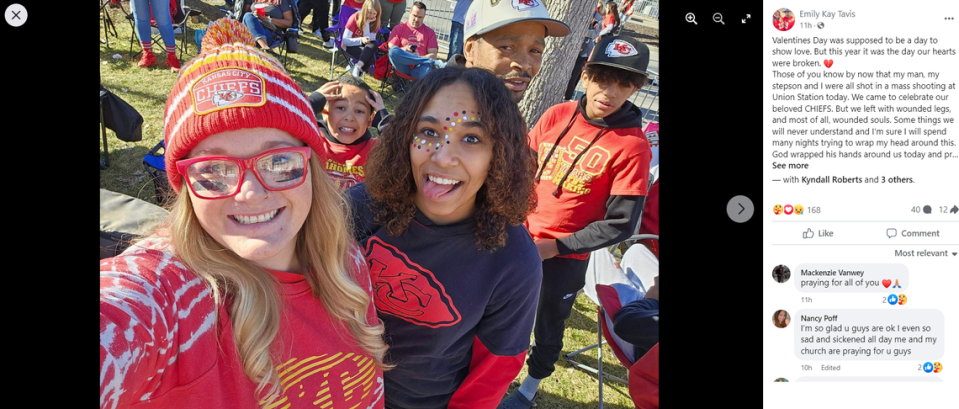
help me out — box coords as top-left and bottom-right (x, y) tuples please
(366, 67), (536, 251)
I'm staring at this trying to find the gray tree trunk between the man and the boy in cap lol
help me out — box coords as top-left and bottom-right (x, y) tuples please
(520, 0), (596, 128)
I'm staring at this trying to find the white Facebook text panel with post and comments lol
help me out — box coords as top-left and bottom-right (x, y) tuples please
(753, 0), (959, 409)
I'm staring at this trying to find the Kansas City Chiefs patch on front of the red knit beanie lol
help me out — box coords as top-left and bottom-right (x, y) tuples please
(190, 67), (266, 115)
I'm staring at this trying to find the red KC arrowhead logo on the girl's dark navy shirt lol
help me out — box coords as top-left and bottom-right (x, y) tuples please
(365, 237), (461, 328)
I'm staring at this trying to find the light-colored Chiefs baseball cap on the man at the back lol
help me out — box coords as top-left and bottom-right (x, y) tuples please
(463, 0), (568, 38)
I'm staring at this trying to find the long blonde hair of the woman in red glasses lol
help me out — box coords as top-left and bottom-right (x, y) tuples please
(169, 152), (392, 404)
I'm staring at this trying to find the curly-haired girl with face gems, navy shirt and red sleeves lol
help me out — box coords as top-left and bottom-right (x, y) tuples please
(346, 67), (542, 409)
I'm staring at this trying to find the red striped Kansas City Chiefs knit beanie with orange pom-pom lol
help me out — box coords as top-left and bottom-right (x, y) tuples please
(163, 18), (323, 193)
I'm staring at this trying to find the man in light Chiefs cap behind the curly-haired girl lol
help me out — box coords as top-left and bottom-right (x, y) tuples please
(447, 0), (569, 103)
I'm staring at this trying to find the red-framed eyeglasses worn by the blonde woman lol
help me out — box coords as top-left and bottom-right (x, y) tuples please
(176, 146), (312, 199)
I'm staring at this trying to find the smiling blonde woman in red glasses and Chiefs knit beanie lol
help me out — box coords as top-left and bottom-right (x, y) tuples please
(100, 19), (386, 409)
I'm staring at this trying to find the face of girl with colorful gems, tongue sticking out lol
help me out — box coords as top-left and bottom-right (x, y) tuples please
(410, 83), (493, 224)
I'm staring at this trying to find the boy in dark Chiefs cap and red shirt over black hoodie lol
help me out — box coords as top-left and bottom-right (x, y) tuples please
(500, 36), (652, 408)
